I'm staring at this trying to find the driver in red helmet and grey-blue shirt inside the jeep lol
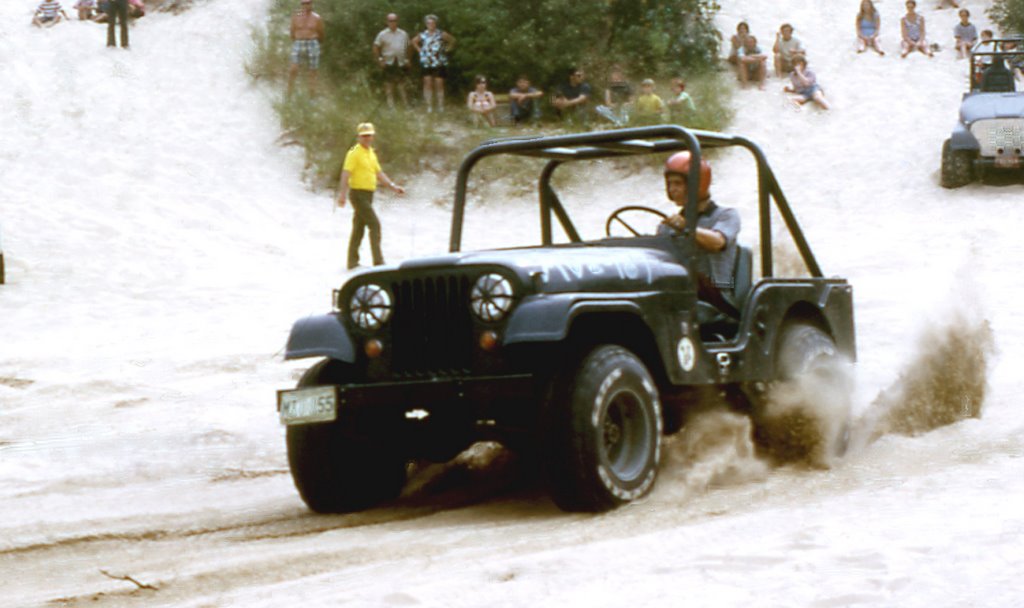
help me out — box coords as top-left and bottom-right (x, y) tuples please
(658, 150), (739, 318)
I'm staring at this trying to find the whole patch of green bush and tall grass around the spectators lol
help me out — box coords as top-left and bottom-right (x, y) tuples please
(246, 0), (731, 186)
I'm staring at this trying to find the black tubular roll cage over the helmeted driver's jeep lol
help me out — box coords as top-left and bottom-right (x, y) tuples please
(449, 125), (823, 278)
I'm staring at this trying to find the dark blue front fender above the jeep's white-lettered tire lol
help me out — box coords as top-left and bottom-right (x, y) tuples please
(505, 294), (643, 344)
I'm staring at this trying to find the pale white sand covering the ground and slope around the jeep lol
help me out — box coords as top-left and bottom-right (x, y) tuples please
(0, 0), (1024, 608)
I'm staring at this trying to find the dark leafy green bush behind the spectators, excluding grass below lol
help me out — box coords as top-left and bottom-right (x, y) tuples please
(307, 0), (720, 90)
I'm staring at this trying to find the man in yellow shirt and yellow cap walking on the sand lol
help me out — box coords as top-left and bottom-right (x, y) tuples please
(338, 123), (406, 270)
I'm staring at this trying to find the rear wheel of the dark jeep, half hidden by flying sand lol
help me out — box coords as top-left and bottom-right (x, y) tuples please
(752, 322), (853, 468)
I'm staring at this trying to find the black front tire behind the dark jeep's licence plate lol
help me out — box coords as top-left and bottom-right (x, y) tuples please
(287, 360), (407, 513)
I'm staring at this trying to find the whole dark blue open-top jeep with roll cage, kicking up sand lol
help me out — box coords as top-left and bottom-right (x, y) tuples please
(278, 125), (855, 512)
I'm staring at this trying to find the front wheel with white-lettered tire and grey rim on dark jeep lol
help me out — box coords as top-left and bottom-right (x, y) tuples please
(542, 345), (662, 512)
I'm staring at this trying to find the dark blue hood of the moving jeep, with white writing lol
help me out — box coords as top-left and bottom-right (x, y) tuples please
(380, 240), (687, 293)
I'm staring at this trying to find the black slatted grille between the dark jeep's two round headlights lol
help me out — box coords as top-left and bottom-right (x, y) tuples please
(391, 274), (474, 377)
